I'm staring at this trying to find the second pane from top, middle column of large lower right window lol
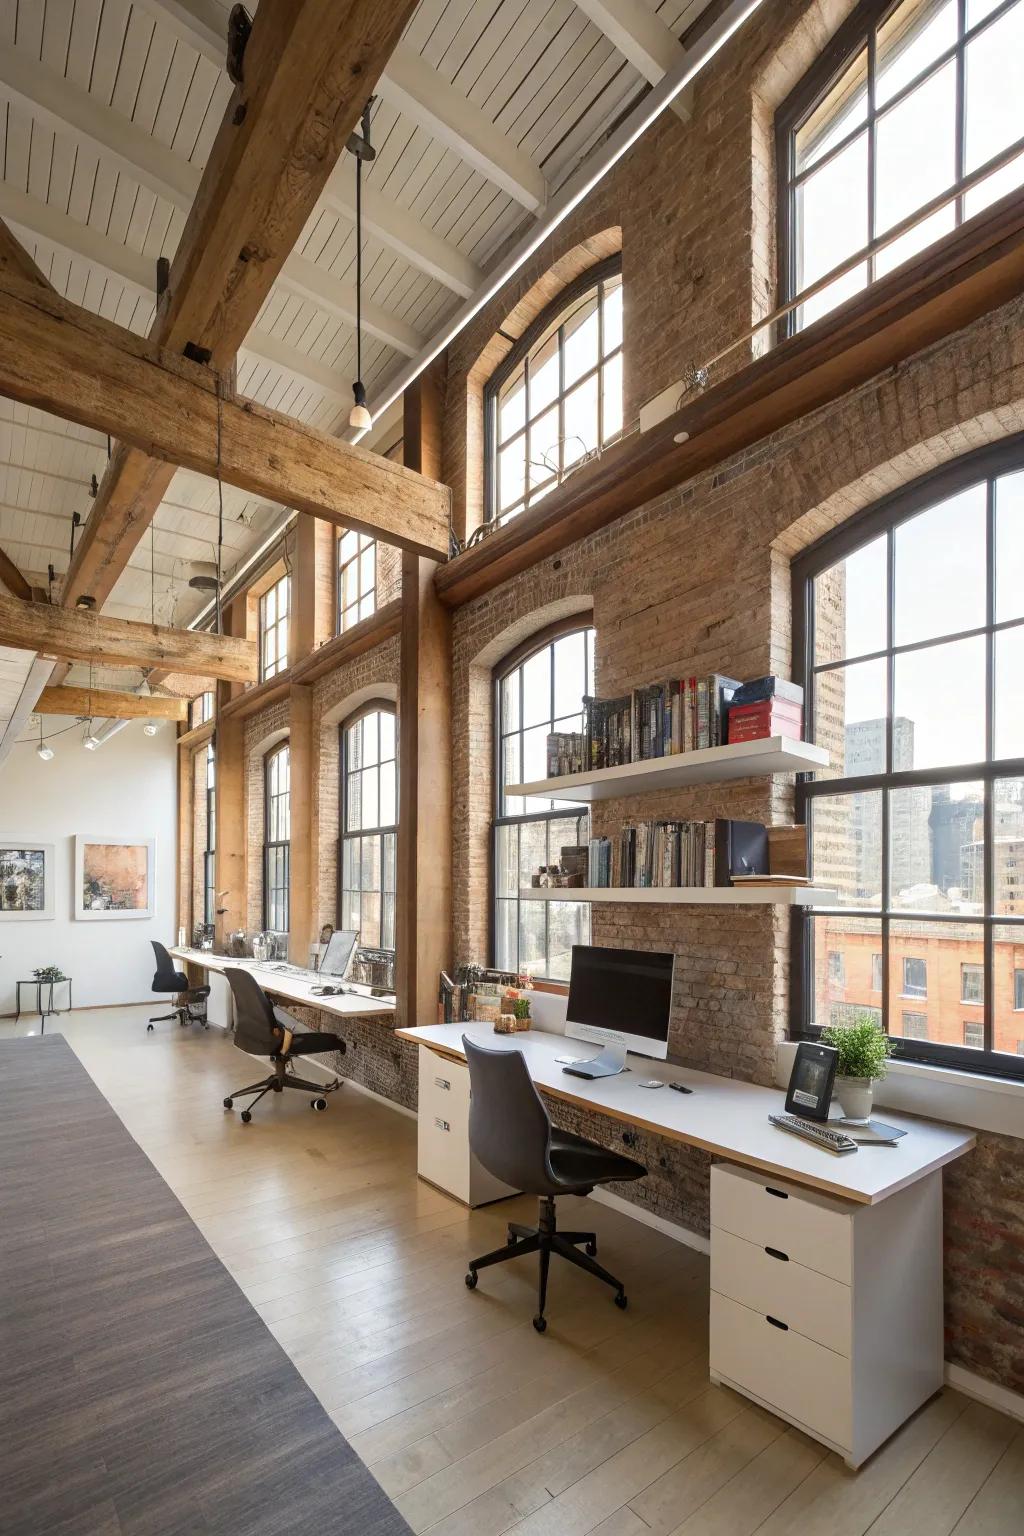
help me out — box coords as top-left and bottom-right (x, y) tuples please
(892, 636), (986, 770)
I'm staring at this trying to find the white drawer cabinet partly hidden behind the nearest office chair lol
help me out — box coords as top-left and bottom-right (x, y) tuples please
(416, 1046), (516, 1206)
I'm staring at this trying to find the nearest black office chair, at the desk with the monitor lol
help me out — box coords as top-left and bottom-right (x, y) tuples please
(462, 1035), (646, 1333)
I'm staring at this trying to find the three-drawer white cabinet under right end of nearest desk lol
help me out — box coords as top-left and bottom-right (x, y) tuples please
(711, 1147), (943, 1467)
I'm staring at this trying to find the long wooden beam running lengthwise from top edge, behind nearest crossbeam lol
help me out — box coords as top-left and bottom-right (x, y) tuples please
(61, 0), (415, 605)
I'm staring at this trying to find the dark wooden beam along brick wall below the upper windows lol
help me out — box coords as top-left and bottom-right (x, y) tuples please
(436, 190), (1024, 607)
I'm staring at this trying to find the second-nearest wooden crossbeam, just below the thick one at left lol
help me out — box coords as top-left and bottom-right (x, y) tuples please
(0, 596), (258, 682)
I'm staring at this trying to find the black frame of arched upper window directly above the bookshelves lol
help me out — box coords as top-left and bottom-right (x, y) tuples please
(484, 250), (625, 524)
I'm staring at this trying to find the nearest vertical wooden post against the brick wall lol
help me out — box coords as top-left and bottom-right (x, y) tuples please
(396, 366), (451, 1025)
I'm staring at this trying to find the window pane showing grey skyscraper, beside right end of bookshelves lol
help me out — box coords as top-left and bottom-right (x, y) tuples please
(889, 782), (984, 915)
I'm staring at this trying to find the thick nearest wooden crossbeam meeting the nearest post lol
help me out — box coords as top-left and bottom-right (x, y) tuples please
(0, 275), (450, 559)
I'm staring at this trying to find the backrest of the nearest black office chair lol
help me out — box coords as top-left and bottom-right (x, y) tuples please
(462, 1035), (551, 1195)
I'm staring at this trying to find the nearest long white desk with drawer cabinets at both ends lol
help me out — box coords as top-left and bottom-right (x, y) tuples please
(396, 1025), (975, 1467)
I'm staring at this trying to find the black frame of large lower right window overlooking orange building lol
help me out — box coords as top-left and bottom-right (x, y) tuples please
(789, 433), (1024, 1080)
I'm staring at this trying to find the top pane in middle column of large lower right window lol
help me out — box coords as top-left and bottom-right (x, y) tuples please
(894, 485), (986, 645)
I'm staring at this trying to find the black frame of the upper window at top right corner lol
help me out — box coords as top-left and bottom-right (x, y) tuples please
(775, 0), (1018, 341)
